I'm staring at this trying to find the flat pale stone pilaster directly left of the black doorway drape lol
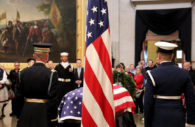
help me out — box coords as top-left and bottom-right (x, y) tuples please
(119, 0), (135, 65)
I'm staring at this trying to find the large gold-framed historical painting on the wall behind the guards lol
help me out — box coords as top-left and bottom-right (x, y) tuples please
(0, 0), (85, 68)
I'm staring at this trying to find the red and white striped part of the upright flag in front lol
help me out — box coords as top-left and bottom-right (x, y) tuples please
(82, 30), (115, 127)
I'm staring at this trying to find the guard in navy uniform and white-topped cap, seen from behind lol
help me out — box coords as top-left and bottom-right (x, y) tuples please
(144, 42), (195, 127)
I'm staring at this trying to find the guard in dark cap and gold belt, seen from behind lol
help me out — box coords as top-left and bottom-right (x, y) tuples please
(16, 43), (58, 127)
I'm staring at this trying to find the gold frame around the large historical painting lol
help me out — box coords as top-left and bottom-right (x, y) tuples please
(0, 0), (86, 70)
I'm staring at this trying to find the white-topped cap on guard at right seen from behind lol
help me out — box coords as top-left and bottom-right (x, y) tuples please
(155, 41), (178, 53)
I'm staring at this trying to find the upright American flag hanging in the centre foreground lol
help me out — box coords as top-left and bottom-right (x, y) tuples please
(82, 0), (115, 127)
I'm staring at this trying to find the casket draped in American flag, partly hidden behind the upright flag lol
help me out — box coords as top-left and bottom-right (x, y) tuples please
(58, 85), (135, 121)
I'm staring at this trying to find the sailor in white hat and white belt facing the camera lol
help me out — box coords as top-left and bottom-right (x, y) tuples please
(55, 52), (76, 103)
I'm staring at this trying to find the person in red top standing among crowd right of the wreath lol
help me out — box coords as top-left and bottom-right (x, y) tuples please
(134, 67), (144, 113)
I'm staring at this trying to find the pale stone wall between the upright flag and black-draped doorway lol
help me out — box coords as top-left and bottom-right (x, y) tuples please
(108, 0), (135, 65)
